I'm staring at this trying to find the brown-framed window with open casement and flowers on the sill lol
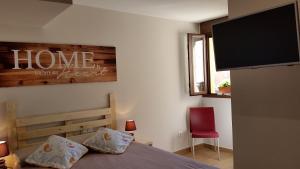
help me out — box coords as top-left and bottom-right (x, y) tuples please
(188, 34), (230, 97)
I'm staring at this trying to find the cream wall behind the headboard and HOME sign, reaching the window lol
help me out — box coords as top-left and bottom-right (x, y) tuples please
(0, 6), (201, 151)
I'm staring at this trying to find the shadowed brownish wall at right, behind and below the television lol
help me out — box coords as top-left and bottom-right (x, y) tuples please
(229, 0), (300, 169)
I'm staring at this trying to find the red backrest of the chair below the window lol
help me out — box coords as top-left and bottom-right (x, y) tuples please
(190, 107), (216, 132)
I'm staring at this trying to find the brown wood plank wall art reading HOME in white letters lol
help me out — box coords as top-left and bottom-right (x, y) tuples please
(0, 42), (117, 87)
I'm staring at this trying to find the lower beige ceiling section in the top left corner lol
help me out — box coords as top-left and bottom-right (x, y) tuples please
(0, 0), (72, 27)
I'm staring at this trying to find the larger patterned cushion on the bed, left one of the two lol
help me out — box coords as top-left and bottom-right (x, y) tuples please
(25, 135), (88, 169)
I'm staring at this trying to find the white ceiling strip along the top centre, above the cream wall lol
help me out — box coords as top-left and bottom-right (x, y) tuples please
(73, 0), (228, 22)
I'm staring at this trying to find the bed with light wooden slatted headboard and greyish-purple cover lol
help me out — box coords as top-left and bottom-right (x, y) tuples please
(6, 94), (217, 169)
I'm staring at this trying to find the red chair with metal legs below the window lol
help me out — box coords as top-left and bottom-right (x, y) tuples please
(190, 107), (220, 160)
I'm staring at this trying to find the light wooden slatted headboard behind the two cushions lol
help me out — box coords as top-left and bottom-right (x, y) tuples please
(6, 94), (116, 153)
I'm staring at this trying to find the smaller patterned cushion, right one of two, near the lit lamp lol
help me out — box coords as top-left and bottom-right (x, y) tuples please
(83, 128), (133, 154)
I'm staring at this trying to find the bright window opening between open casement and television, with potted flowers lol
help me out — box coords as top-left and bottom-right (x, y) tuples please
(209, 38), (230, 95)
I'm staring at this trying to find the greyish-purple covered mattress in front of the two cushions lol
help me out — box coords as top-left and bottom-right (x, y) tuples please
(22, 143), (217, 169)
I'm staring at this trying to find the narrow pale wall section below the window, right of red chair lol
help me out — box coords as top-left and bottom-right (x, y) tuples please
(202, 98), (233, 149)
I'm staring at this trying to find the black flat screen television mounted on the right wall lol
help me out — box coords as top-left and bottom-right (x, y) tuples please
(213, 3), (299, 71)
